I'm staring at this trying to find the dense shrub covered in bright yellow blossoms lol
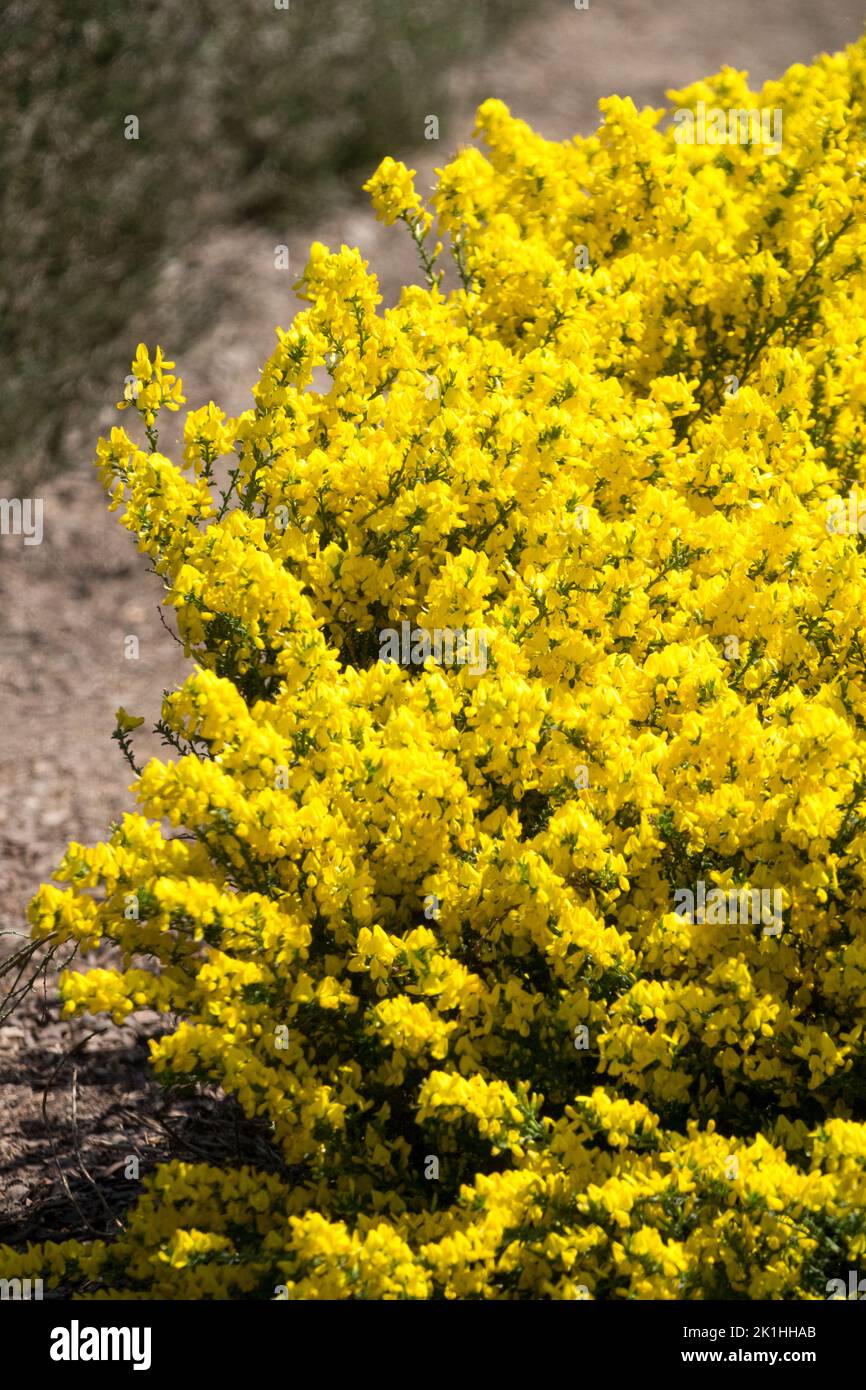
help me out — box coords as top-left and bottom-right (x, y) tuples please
(3, 42), (866, 1298)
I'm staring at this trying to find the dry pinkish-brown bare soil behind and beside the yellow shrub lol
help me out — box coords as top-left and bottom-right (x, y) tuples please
(0, 0), (866, 1262)
